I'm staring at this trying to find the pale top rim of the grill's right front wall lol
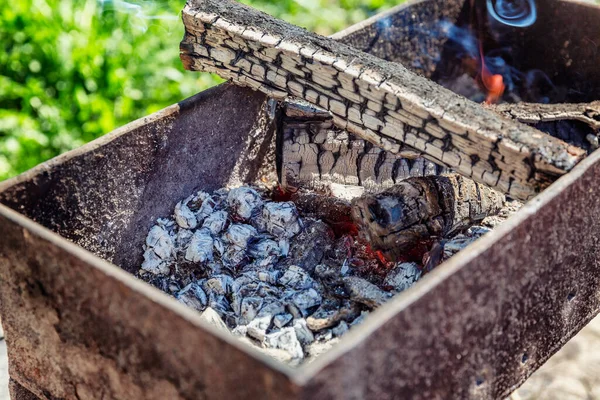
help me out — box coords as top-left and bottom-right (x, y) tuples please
(295, 145), (600, 382)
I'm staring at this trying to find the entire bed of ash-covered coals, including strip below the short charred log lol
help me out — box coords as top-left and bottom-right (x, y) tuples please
(138, 187), (516, 365)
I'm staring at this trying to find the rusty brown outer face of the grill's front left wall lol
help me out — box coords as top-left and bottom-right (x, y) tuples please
(0, 206), (294, 400)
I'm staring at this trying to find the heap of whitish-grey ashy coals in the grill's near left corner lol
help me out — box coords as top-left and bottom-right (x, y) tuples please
(140, 187), (391, 365)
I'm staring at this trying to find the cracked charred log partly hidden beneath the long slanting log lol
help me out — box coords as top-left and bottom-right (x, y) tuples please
(277, 101), (446, 192)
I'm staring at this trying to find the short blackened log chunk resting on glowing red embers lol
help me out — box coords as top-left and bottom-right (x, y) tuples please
(352, 174), (505, 260)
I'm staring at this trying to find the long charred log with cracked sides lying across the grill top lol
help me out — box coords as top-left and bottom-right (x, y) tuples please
(181, 0), (585, 200)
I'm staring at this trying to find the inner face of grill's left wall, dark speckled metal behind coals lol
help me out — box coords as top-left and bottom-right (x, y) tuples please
(0, 85), (273, 272)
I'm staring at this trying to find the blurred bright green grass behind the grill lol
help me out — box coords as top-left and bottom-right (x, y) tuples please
(0, 0), (403, 180)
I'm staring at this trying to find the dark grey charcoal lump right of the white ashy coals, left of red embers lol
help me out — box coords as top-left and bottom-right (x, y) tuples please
(286, 221), (335, 273)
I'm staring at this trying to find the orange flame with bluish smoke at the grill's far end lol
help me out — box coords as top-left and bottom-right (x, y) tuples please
(426, 0), (567, 104)
